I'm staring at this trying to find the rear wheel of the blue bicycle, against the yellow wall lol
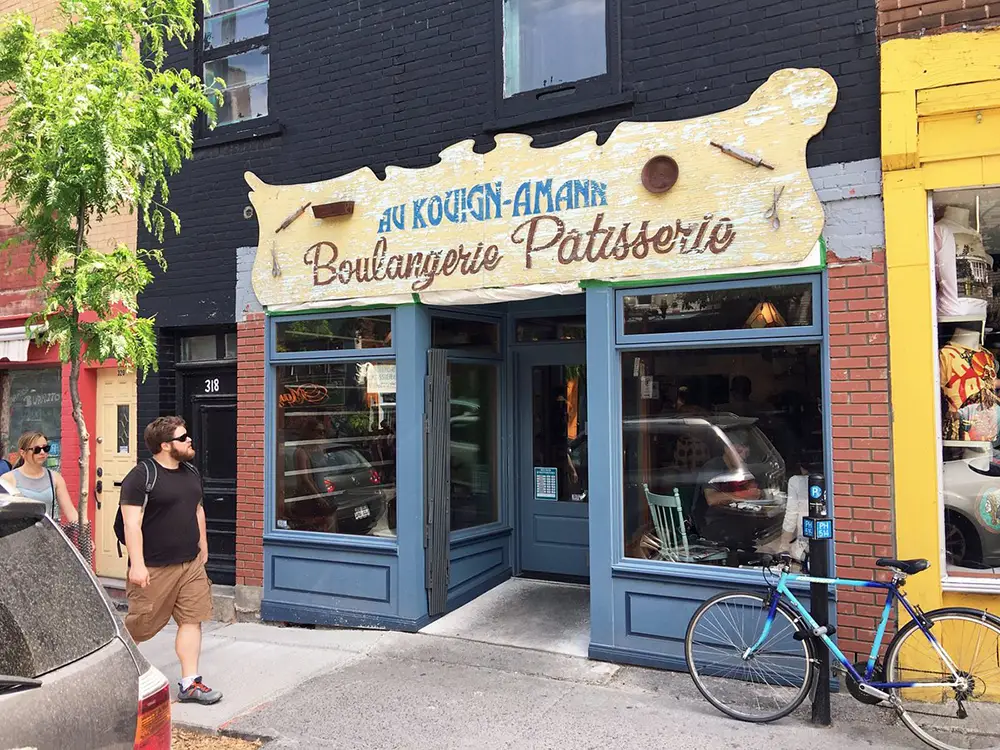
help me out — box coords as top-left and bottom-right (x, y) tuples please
(885, 607), (1000, 750)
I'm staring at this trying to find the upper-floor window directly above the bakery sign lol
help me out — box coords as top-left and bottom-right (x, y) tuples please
(503, 0), (608, 98)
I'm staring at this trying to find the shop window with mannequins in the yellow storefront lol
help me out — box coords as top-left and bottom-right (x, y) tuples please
(931, 187), (1000, 577)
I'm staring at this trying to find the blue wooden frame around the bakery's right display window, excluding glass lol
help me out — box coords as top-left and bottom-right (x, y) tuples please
(587, 272), (836, 670)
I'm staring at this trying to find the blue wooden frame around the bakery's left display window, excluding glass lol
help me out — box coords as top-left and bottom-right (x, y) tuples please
(261, 304), (430, 631)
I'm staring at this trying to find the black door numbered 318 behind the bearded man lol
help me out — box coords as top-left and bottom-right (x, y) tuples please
(184, 367), (236, 586)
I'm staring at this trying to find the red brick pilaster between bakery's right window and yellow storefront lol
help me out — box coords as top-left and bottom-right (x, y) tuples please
(828, 251), (894, 659)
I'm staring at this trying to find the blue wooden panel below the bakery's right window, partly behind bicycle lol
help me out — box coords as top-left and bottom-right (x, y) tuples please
(590, 571), (834, 670)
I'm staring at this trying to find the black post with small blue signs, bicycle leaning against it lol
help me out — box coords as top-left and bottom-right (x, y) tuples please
(802, 474), (833, 726)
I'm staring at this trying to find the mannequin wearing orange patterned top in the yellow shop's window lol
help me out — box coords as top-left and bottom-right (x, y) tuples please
(938, 326), (997, 442)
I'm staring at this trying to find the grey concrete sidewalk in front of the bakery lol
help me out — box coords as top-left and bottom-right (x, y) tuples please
(142, 624), (921, 750)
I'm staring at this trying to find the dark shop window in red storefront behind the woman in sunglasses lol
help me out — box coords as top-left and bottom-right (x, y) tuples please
(3, 374), (62, 471)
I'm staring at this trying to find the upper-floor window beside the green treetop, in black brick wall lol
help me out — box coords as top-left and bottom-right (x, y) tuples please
(202, 0), (270, 126)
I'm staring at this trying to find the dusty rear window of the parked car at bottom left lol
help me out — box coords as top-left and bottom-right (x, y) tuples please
(0, 518), (117, 677)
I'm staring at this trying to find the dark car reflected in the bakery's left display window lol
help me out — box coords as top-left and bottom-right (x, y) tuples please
(284, 445), (389, 534)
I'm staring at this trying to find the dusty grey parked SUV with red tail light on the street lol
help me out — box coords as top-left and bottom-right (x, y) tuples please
(0, 485), (170, 750)
